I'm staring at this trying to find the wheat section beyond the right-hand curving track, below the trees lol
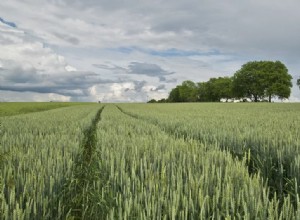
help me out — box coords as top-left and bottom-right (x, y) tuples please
(120, 103), (300, 210)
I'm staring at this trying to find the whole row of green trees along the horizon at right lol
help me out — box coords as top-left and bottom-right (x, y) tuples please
(149, 61), (300, 102)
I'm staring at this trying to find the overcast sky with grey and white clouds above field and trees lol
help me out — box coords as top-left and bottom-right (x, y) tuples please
(0, 0), (300, 102)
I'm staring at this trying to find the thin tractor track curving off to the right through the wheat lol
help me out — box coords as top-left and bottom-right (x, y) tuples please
(116, 105), (297, 210)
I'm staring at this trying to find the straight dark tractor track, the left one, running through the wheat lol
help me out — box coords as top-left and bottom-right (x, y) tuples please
(62, 106), (105, 219)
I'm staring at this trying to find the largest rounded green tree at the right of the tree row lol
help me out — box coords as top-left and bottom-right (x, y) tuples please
(233, 61), (292, 102)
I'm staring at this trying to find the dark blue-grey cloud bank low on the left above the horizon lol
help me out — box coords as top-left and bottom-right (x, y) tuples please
(0, 61), (121, 96)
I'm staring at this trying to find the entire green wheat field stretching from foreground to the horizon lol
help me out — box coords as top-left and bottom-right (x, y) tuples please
(0, 103), (300, 220)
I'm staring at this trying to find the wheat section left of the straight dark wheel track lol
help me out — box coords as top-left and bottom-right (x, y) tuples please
(0, 105), (101, 220)
